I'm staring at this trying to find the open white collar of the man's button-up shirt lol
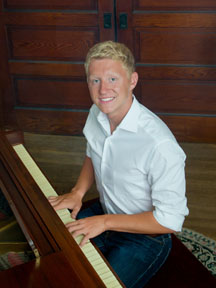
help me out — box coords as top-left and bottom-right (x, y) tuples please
(97, 95), (140, 134)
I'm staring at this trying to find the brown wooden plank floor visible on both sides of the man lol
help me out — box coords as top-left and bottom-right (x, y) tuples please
(25, 133), (216, 240)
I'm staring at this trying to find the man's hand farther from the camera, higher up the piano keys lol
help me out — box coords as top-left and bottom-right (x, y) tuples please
(48, 190), (82, 219)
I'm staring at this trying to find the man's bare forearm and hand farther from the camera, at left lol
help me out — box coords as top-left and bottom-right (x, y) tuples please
(48, 156), (94, 219)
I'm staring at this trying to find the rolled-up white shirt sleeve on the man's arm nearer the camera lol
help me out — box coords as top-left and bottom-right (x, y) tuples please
(149, 141), (189, 231)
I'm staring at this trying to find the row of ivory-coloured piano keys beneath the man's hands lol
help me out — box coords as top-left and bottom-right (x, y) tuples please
(13, 144), (122, 288)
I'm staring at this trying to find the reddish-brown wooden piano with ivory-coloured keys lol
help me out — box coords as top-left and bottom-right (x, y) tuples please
(0, 131), (124, 288)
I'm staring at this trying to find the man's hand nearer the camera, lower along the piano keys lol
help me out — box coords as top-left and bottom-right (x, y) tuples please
(66, 215), (106, 247)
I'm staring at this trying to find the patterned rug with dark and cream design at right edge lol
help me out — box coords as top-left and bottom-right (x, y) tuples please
(176, 228), (216, 277)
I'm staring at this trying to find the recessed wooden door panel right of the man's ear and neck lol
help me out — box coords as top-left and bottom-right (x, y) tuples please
(140, 80), (216, 115)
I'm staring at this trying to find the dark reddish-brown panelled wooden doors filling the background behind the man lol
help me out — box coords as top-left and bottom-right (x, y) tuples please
(0, 0), (216, 142)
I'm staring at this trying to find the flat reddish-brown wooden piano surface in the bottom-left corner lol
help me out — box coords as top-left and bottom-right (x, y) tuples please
(0, 252), (89, 288)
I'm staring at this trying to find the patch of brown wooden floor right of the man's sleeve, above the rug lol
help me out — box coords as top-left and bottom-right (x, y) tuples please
(181, 143), (216, 240)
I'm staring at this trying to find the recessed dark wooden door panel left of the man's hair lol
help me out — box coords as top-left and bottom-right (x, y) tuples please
(8, 26), (98, 61)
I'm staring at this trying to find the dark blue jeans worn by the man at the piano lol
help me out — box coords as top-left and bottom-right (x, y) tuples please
(77, 202), (172, 288)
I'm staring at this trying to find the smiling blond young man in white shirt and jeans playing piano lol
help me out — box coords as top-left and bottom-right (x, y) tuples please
(50, 41), (188, 288)
